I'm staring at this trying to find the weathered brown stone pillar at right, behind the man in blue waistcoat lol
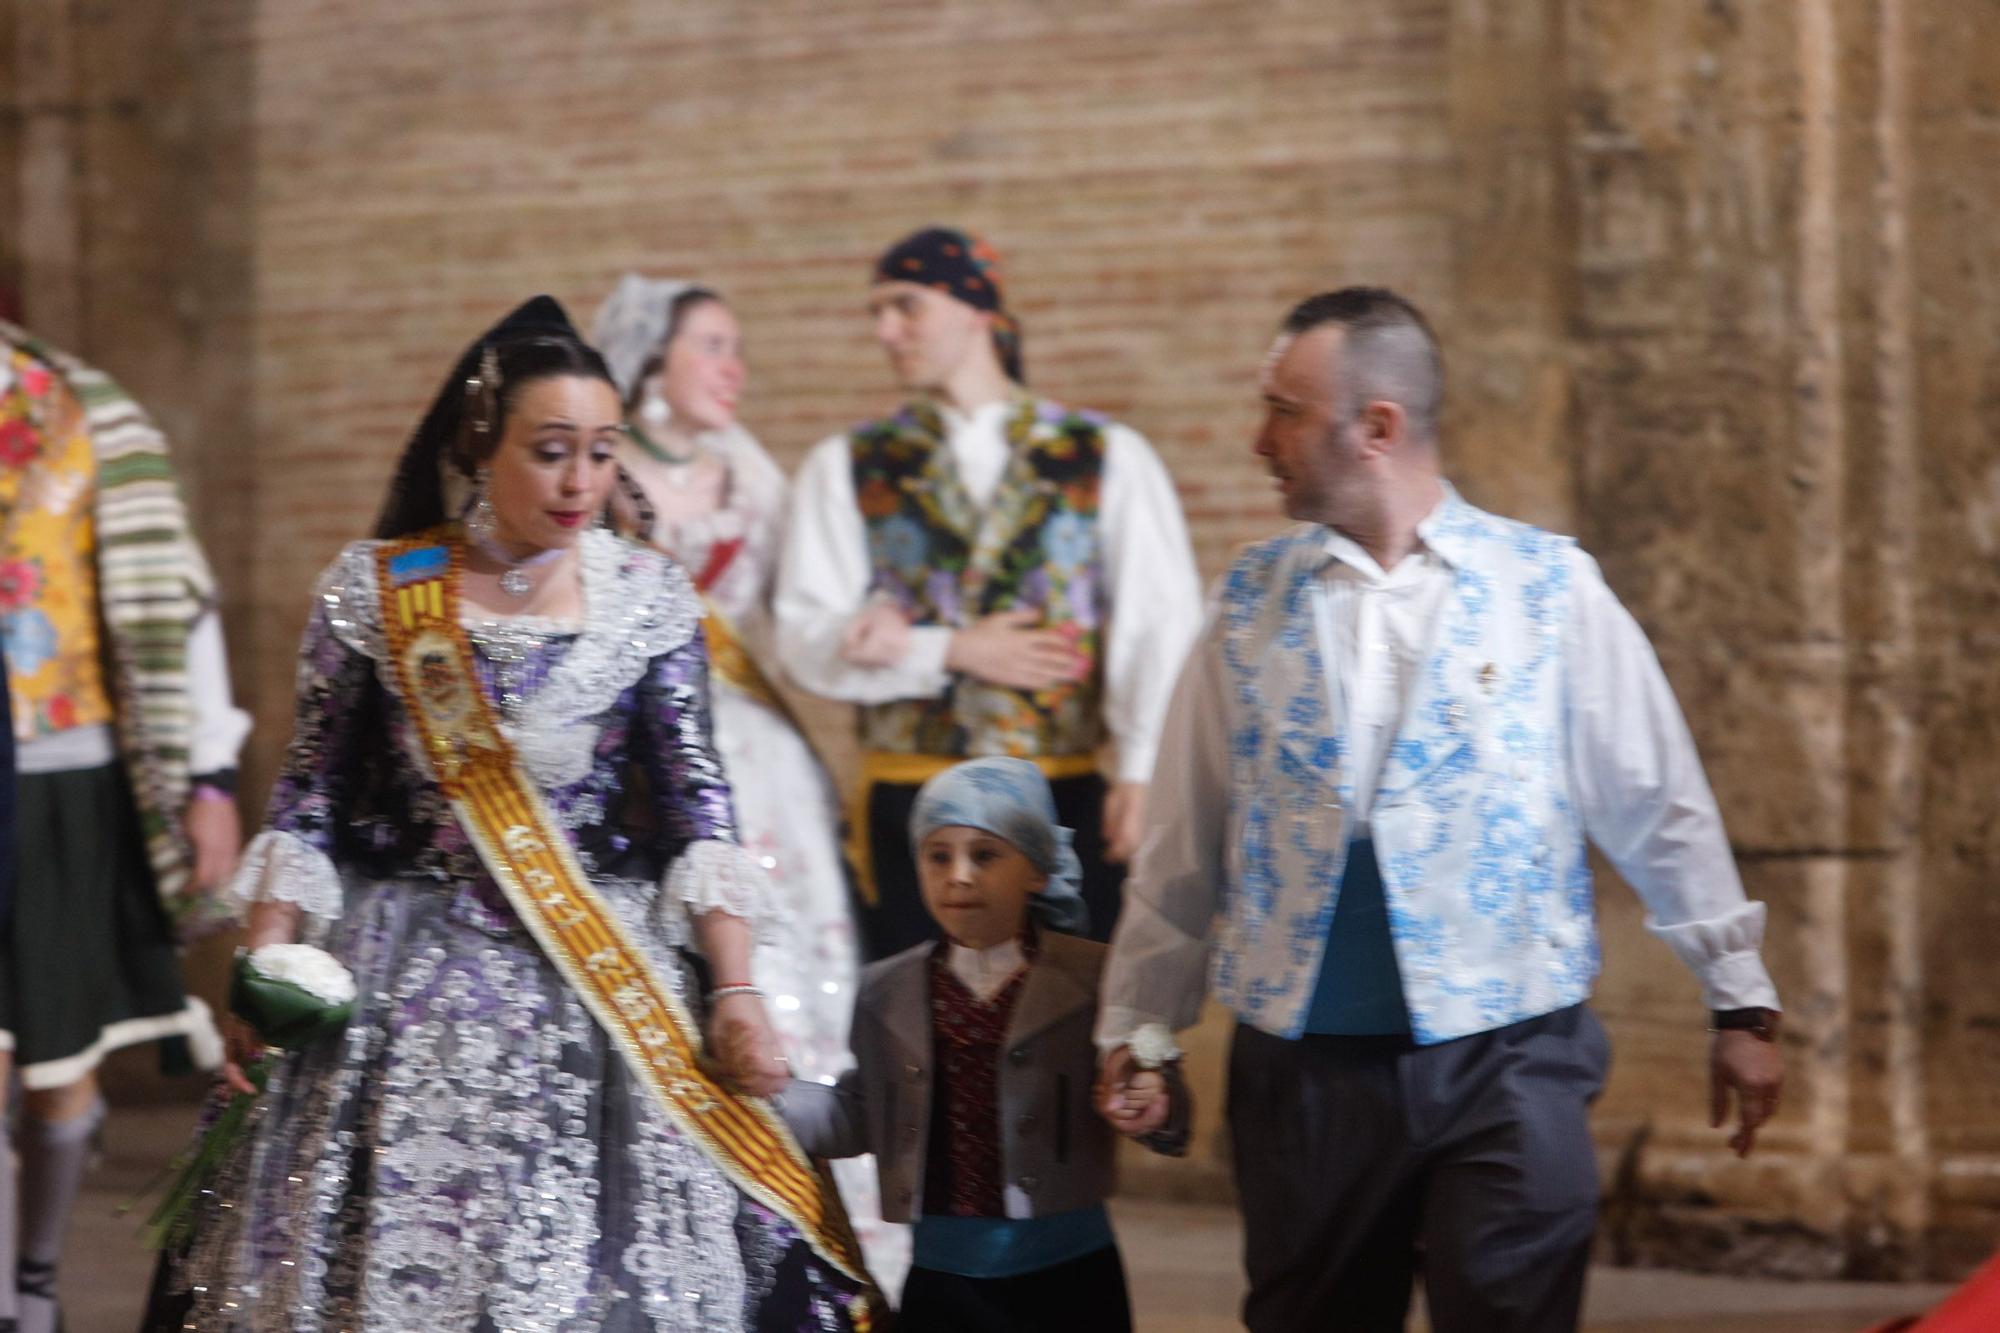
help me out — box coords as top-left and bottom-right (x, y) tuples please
(1560, 0), (2000, 1275)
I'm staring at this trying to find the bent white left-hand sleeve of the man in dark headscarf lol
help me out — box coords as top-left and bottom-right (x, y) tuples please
(772, 434), (952, 705)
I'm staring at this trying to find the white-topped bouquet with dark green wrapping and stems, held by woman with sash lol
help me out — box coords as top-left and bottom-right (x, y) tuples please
(146, 945), (356, 1249)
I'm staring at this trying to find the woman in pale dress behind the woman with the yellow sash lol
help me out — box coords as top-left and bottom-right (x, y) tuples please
(590, 272), (910, 1293)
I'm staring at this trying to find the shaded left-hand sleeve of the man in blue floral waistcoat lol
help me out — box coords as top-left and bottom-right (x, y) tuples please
(1096, 616), (1230, 1051)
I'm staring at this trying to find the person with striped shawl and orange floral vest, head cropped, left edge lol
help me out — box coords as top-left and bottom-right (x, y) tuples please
(0, 322), (250, 1333)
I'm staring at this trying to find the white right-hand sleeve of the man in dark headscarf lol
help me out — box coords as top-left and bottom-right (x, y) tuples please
(1098, 424), (1202, 783)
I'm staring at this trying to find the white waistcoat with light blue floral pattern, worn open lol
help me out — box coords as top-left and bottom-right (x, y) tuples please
(1210, 496), (1598, 1045)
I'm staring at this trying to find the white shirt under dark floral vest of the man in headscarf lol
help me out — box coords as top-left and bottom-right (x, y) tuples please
(774, 400), (1202, 783)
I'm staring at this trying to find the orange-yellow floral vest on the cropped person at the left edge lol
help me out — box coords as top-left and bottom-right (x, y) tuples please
(0, 352), (112, 741)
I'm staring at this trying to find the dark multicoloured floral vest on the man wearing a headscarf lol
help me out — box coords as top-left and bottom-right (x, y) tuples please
(848, 394), (1106, 759)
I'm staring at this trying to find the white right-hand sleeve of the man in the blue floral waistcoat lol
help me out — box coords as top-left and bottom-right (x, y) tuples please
(1566, 550), (1778, 1009)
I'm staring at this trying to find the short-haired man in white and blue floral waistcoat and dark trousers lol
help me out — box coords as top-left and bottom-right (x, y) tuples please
(1098, 288), (1784, 1333)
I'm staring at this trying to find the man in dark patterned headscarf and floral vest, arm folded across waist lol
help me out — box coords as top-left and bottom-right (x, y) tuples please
(776, 228), (1200, 959)
